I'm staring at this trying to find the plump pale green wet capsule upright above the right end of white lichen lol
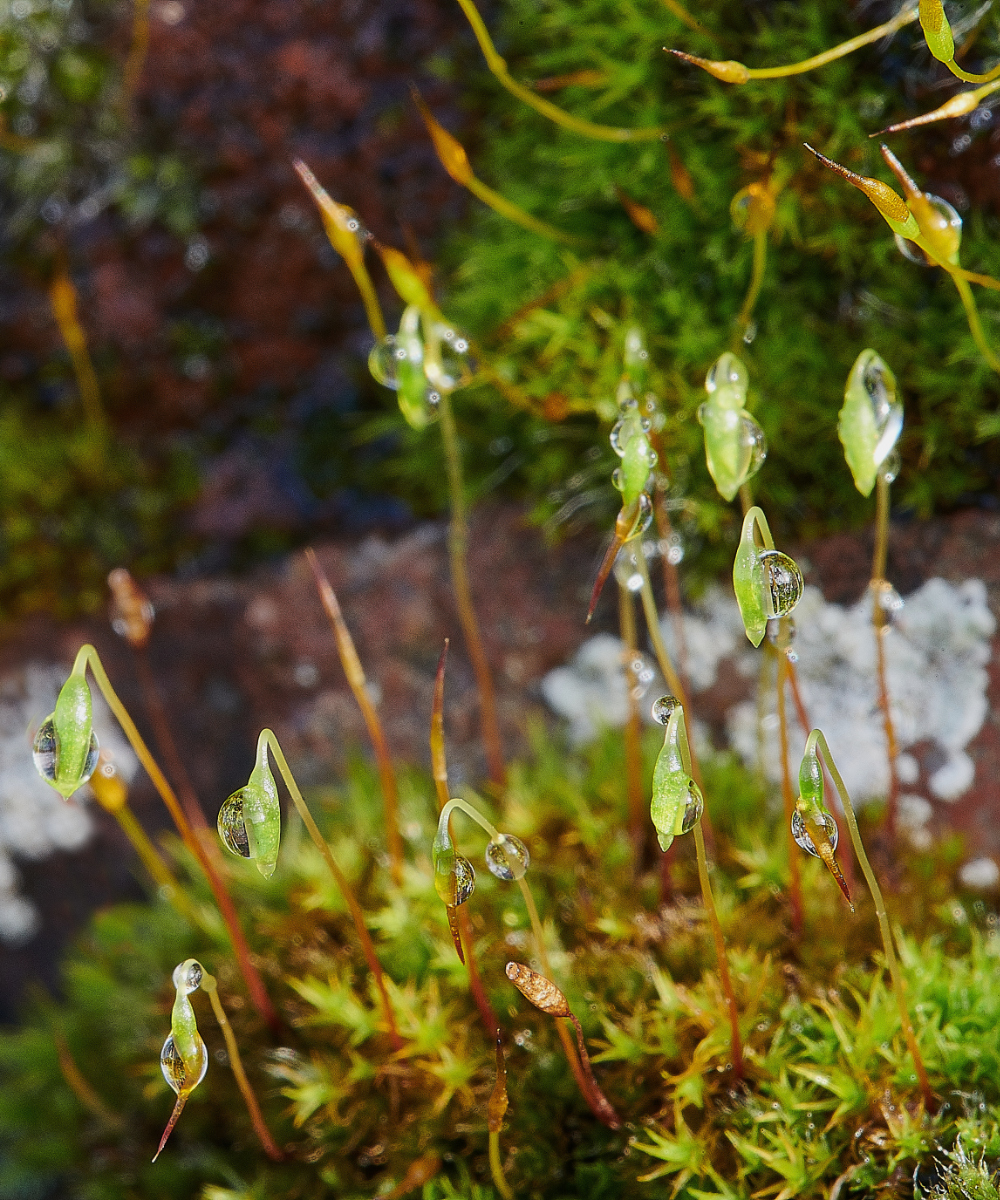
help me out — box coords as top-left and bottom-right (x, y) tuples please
(837, 349), (903, 496)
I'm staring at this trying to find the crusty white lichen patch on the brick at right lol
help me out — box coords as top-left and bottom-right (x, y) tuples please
(541, 578), (995, 825)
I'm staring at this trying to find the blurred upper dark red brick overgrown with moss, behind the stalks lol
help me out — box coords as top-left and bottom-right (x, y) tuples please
(0, 0), (1000, 616)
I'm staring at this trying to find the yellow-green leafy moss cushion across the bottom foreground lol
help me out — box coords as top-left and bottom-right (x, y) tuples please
(0, 728), (1000, 1200)
